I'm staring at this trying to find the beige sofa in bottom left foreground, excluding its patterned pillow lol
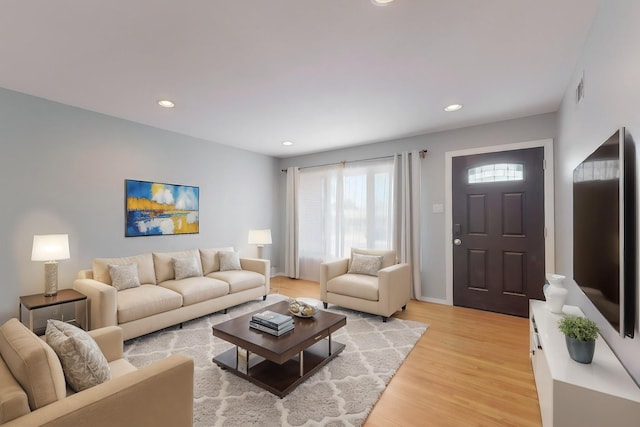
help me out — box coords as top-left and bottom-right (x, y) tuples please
(0, 319), (194, 427)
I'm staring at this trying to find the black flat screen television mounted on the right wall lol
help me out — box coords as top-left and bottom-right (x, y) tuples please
(573, 128), (637, 337)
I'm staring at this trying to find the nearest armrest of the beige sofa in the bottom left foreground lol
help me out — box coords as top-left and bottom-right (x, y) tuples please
(3, 355), (194, 427)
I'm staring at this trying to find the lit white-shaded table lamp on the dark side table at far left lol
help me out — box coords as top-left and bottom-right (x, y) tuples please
(31, 234), (69, 297)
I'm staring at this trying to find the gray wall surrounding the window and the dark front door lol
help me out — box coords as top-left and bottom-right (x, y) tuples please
(277, 114), (556, 300)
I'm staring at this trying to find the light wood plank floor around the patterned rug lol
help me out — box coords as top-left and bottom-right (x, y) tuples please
(271, 277), (541, 427)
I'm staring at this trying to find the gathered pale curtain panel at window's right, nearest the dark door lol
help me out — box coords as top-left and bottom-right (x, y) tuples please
(394, 151), (422, 299)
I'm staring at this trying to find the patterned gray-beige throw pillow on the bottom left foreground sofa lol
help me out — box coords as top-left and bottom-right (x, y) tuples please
(45, 320), (111, 392)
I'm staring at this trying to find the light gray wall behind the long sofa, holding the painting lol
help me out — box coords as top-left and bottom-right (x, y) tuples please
(0, 89), (280, 321)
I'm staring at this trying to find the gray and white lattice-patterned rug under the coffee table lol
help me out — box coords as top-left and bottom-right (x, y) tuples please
(124, 295), (428, 426)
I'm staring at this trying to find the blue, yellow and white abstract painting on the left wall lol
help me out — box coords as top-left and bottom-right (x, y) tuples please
(125, 179), (200, 237)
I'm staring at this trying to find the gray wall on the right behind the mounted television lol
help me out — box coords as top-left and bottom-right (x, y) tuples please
(555, 0), (640, 383)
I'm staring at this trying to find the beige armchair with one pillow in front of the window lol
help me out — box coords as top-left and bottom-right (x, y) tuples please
(320, 249), (411, 322)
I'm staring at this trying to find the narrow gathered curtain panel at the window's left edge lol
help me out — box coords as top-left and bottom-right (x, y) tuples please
(284, 167), (300, 279)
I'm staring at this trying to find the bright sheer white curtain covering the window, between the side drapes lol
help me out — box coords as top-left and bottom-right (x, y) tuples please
(297, 158), (394, 281)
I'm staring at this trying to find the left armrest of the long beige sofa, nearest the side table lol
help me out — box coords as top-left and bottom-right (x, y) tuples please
(73, 279), (118, 329)
